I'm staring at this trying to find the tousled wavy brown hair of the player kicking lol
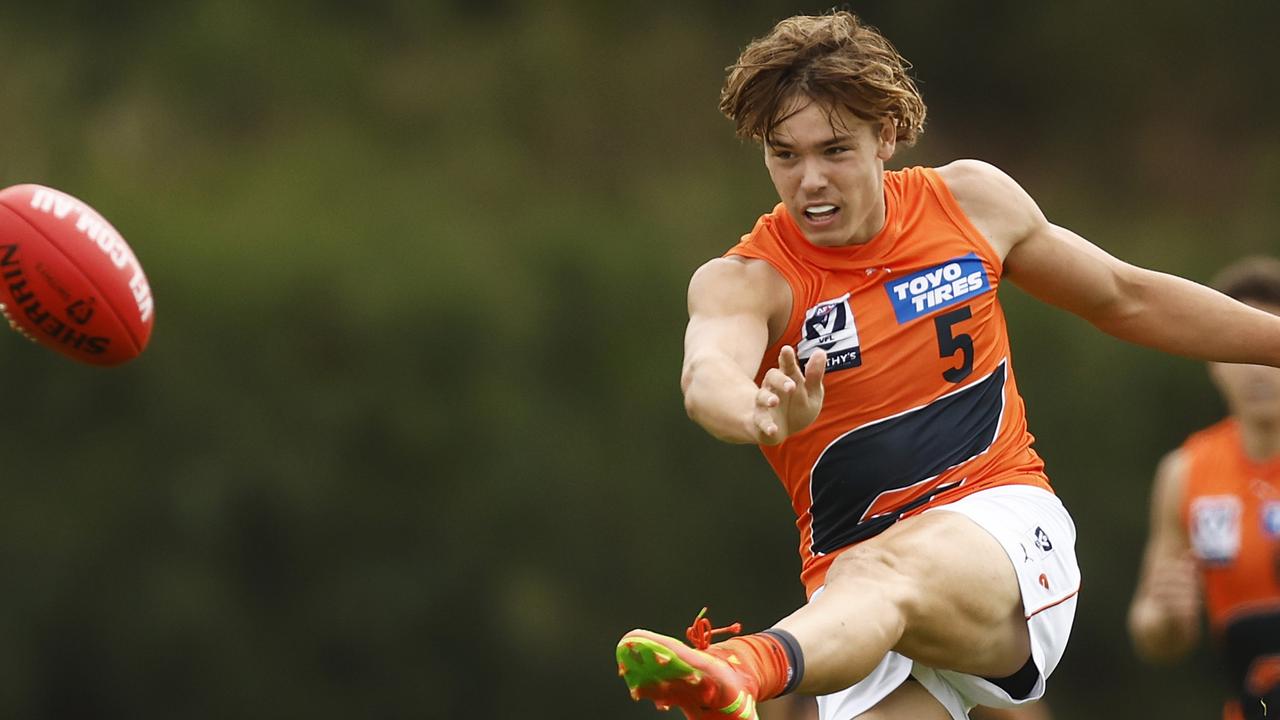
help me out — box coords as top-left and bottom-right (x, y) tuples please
(719, 12), (925, 145)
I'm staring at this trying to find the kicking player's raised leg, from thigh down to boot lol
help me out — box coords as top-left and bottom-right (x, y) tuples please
(618, 511), (1030, 720)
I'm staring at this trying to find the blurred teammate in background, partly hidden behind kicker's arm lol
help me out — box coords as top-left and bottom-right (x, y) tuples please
(1129, 258), (1280, 720)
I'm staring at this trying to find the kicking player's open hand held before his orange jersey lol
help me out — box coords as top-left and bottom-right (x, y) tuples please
(751, 345), (827, 445)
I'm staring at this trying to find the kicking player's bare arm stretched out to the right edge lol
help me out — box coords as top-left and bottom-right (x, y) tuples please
(938, 160), (1280, 366)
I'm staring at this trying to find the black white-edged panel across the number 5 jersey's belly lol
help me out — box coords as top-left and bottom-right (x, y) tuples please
(810, 363), (1005, 552)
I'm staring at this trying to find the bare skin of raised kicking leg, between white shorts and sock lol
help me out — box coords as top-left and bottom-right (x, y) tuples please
(777, 511), (1030, 694)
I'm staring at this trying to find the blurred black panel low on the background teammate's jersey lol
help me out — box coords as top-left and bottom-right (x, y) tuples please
(1221, 612), (1280, 720)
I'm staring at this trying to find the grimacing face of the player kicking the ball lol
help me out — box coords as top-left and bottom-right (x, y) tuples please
(764, 99), (895, 247)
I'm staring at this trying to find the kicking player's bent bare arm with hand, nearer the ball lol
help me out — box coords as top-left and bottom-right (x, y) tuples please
(681, 252), (826, 445)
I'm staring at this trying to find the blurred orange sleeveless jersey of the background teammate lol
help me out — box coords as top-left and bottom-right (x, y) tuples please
(1181, 418), (1280, 717)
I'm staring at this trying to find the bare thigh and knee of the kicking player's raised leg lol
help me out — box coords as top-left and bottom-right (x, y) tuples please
(824, 510), (1030, 678)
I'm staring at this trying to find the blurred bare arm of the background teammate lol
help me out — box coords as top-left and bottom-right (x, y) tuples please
(1129, 450), (1201, 662)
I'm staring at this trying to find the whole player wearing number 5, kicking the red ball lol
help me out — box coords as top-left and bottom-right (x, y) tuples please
(617, 13), (1280, 720)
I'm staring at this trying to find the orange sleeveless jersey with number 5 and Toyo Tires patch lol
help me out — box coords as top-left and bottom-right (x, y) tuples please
(727, 168), (1048, 594)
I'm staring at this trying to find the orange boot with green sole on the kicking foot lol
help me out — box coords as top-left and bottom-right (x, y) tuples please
(617, 607), (759, 720)
